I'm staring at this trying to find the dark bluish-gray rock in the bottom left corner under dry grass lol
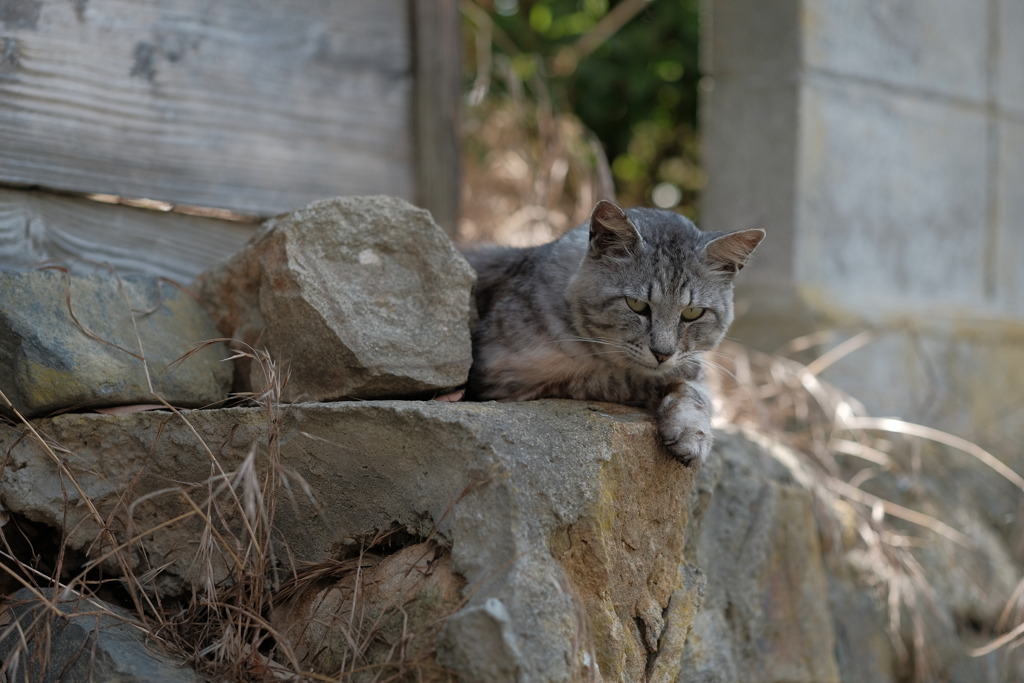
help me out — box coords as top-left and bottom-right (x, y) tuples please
(0, 588), (203, 683)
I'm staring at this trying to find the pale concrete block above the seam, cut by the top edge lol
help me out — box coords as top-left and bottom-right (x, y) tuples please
(801, 0), (987, 102)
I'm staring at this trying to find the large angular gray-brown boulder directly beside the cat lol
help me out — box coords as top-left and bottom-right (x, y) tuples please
(194, 197), (476, 401)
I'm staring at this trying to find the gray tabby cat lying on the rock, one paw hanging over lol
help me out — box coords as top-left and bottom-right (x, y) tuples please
(466, 201), (765, 466)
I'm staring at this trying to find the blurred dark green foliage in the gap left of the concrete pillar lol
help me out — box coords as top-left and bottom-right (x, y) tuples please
(478, 0), (703, 217)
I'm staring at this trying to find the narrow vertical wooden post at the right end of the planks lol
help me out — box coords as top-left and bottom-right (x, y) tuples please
(413, 0), (462, 238)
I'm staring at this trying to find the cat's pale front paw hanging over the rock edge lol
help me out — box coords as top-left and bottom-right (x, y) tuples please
(657, 378), (713, 467)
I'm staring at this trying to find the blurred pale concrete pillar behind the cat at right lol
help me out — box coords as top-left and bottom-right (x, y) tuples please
(701, 0), (1024, 454)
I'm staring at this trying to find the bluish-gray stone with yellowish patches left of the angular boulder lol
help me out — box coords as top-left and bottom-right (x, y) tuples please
(0, 269), (231, 417)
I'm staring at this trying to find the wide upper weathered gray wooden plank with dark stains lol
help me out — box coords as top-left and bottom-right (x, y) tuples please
(0, 0), (415, 215)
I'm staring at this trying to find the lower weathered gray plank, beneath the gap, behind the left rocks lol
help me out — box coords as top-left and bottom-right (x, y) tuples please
(0, 188), (258, 285)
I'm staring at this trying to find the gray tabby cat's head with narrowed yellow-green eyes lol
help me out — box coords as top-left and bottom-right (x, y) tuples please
(568, 201), (765, 374)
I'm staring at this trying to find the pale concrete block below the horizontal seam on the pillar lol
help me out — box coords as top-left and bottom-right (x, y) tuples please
(795, 82), (989, 321)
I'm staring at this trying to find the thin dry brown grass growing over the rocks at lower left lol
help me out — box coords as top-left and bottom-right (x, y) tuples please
(0, 303), (468, 681)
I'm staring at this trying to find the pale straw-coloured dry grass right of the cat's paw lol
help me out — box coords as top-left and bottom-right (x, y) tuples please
(707, 332), (1024, 681)
